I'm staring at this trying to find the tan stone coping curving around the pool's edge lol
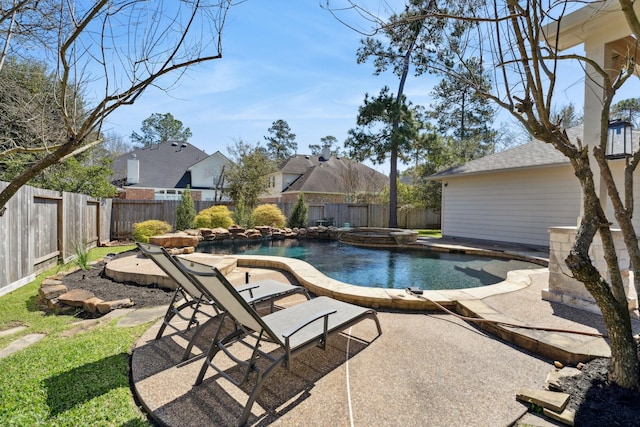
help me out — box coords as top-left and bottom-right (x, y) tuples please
(107, 239), (548, 310)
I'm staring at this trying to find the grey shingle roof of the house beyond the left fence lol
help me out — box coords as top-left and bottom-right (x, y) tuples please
(112, 142), (208, 188)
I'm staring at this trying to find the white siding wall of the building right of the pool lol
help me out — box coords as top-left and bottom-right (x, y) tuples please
(442, 166), (580, 246)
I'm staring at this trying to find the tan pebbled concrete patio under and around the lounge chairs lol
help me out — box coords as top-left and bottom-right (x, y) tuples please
(125, 239), (640, 426)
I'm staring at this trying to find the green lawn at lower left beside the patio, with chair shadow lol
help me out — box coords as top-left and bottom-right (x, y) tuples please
(0, 246), (150, 427)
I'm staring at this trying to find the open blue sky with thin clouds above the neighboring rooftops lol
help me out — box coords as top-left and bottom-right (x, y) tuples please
(104, 0), (584, 174)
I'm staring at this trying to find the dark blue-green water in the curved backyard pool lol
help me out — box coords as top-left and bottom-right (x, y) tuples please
(197, 239), (542, 290)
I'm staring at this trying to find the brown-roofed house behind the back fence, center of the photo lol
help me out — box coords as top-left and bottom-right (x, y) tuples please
(261, 151), (389, 203)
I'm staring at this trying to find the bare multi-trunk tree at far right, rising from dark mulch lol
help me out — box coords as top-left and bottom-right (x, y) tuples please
(476, 0), (640, 388)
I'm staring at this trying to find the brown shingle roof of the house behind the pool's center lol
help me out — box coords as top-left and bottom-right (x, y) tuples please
(280, 155), (389, 193)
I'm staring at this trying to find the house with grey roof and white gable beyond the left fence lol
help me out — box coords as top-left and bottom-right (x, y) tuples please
(112, 142), (231, 201)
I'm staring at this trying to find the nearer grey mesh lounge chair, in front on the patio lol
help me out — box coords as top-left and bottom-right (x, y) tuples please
(171, 259), (382, 425)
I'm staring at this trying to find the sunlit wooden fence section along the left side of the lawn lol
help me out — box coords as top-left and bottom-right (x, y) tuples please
(0, 181), (111, 295)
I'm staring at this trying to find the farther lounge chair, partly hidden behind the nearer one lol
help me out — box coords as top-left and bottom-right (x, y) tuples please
(137, 243), (310, 360)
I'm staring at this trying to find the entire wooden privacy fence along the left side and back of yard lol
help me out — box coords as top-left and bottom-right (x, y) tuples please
(0, 181), (440, 296)
